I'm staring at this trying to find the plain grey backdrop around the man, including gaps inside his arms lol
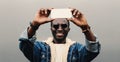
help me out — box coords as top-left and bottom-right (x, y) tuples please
(0, 0), (120, 62)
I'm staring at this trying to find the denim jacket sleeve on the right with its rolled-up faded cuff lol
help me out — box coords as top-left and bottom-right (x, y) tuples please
(78, 34), (100, 62)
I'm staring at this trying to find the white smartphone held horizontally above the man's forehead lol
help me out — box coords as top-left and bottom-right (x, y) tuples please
(50, 8), (72, 18)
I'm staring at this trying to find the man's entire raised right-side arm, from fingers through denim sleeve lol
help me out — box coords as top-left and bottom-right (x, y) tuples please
(70, 9), (100, 62)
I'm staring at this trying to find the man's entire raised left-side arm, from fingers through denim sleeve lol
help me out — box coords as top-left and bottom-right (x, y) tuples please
(19, 9), (52, 62)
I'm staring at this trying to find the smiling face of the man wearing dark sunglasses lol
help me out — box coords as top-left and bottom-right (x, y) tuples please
(51, 18), (70, 43)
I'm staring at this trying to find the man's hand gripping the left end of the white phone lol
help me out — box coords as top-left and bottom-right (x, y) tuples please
(33, 8), (53, 25)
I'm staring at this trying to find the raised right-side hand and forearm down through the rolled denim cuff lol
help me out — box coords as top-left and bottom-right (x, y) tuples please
(70, 9), (100, 52)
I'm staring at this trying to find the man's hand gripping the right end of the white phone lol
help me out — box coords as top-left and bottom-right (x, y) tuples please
(69, 9), (89, 29)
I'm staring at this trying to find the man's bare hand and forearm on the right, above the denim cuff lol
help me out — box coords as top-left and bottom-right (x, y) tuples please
(70, 9), (96, 42)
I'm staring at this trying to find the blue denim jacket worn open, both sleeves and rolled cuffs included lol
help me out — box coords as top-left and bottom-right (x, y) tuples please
(19, 29), (100, 62)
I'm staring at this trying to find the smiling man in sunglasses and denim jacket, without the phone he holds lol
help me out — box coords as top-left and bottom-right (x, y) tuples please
(19, 9), (100, 62)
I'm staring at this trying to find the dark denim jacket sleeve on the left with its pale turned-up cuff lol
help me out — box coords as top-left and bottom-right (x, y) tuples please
(19, 29), (36, 62)
